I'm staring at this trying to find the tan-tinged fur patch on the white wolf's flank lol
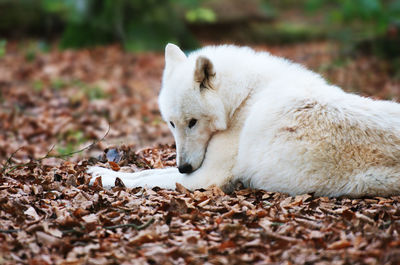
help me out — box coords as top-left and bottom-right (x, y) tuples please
(277, 99), (400, 194)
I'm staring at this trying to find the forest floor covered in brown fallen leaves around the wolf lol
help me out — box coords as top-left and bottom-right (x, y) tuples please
(0, 42), (400, 264)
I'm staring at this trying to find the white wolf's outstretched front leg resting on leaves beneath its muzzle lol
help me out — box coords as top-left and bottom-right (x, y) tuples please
(88, 127), (238, 190)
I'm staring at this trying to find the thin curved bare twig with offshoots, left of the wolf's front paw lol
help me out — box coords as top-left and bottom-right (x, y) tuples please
(1, 124), (111, 174)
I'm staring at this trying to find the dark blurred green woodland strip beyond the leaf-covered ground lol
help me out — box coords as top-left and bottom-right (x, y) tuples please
(0, 0), (400, 54)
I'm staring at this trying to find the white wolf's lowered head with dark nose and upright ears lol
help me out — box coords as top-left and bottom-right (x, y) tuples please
(159, 44), (227, 173)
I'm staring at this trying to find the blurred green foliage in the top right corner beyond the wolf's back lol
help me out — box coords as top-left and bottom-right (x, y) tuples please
(305, 0), (400, 62)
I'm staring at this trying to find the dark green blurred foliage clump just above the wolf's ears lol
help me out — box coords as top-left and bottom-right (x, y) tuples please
(41, 0), (200, 51)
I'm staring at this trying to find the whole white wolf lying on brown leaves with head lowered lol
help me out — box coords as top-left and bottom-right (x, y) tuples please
(88, 44), (400, 197)
